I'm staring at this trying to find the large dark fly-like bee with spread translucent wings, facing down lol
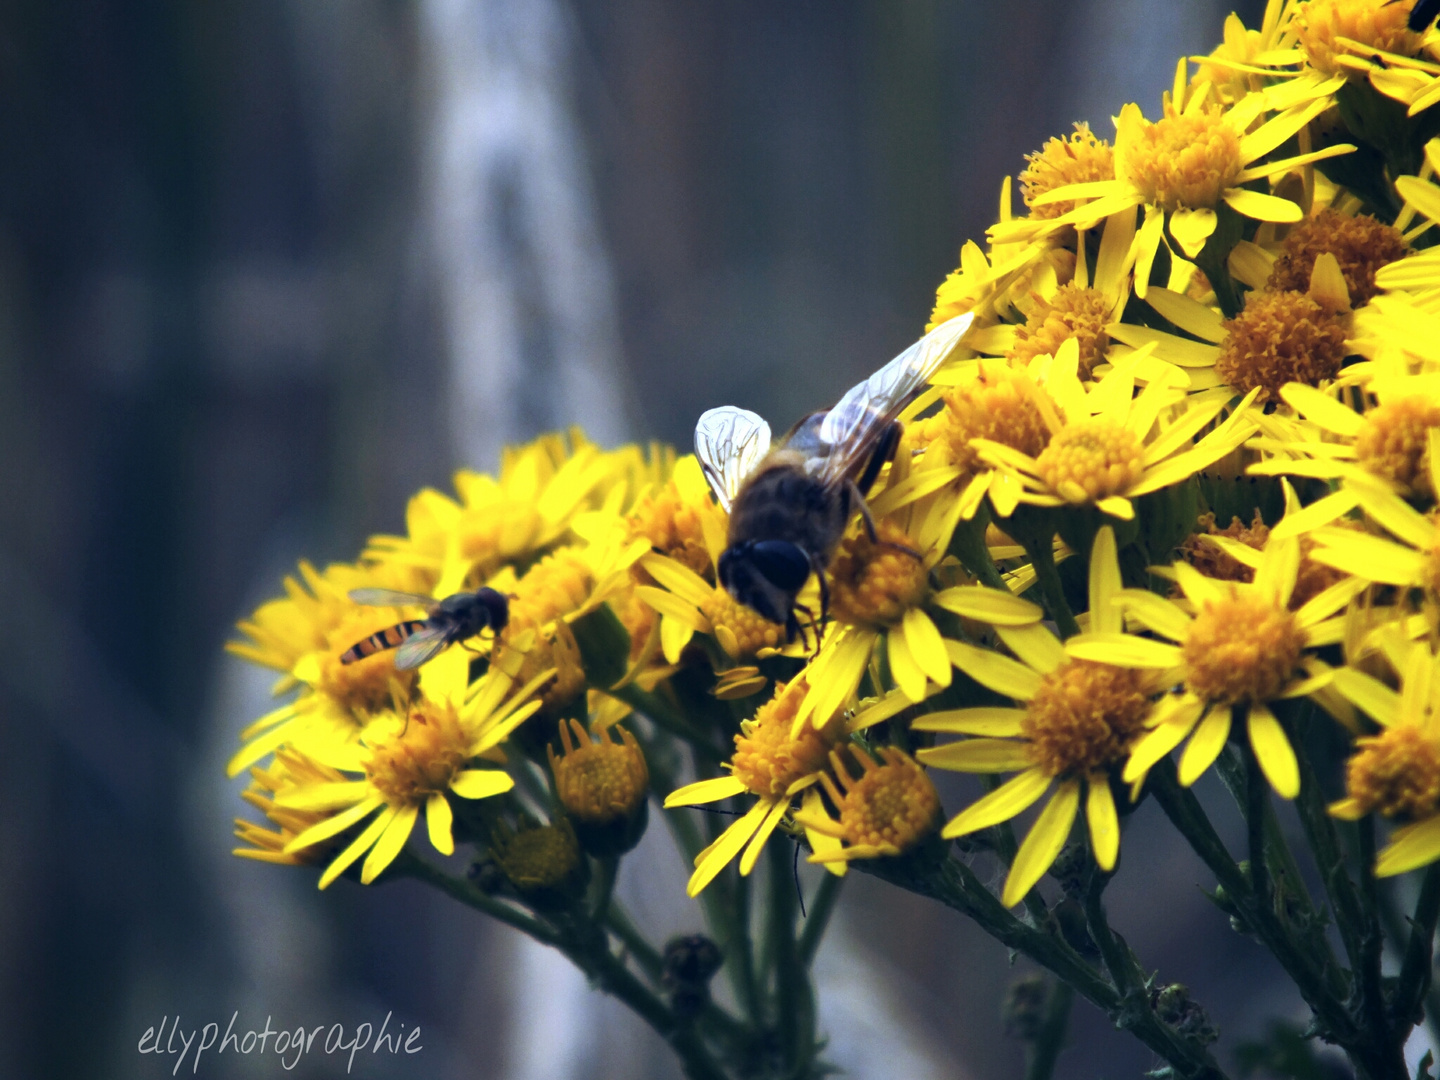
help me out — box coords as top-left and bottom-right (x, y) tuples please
(696, 314), (973, 641)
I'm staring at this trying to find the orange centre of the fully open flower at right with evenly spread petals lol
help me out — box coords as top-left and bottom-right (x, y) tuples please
(1181, 586), (1305, 704)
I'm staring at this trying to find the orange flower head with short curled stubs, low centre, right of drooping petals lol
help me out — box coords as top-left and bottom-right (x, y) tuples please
(821, 746), (940, 855)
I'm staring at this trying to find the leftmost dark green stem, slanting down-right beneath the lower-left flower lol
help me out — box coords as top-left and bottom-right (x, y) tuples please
(396, 852), (727, 1080)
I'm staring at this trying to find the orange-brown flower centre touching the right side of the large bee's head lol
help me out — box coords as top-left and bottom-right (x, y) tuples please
(829, 521), (930, 626)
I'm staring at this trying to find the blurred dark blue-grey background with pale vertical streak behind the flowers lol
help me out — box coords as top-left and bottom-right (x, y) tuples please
(0, 0), (1319, 1080)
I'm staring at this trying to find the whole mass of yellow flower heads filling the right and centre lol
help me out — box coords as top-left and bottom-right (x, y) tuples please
(218, 12), (1440, 1077)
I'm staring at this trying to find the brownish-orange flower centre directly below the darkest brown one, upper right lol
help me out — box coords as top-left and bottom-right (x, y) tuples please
(1215, 289), (1346, 400)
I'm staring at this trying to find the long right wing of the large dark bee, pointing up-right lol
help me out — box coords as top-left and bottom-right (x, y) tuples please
(819, 314), (975, 484)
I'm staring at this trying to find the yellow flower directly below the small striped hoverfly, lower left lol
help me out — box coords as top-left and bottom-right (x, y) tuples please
(275, 649), (553, 888)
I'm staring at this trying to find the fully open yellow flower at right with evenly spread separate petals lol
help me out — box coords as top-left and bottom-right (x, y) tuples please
(1066, 536), (1354, 799)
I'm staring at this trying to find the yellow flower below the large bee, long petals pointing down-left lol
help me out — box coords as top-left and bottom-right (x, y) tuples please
(665, 685), (845, 896)
